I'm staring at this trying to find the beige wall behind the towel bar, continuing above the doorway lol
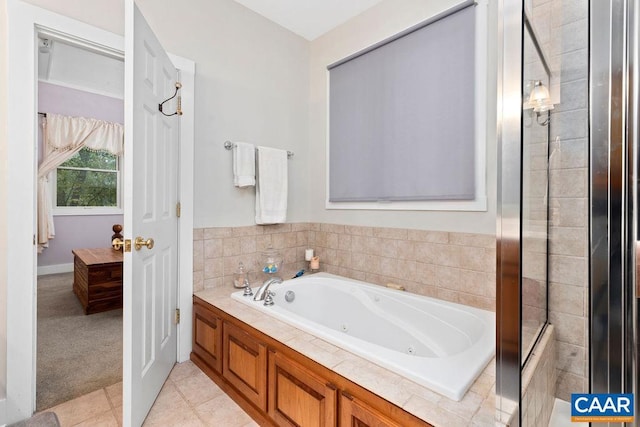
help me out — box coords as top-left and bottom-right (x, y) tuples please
(27, 0), (309, 227)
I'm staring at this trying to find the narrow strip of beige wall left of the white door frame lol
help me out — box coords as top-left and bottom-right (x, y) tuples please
(0, 0), (8, 404)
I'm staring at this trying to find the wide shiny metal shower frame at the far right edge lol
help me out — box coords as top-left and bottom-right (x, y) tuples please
(589, 0), (640, 426)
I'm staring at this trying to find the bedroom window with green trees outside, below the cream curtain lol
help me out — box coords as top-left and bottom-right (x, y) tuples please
(53, 148), (120, 214)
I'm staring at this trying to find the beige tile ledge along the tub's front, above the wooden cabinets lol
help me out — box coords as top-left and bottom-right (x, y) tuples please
(195, 287), (496, 427)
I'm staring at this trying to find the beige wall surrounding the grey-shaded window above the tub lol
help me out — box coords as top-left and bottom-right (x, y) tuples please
(308, 0), (497, 234)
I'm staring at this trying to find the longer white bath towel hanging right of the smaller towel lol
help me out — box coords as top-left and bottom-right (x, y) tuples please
(256, 147), (289, 224)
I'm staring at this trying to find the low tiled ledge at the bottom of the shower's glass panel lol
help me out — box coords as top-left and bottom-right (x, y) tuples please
(520, 325), (558, 427)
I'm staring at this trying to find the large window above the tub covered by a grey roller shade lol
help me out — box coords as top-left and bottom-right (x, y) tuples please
(327, 1), (487, 211)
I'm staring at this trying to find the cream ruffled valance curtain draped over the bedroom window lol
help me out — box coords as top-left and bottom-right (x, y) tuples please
(38, 113), (124, 253)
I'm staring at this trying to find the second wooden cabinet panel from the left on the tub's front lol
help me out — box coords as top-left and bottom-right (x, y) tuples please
(222, 321), (267, 411)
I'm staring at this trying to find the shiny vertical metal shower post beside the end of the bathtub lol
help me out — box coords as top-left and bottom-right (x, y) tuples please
(496, 0), (524, 426)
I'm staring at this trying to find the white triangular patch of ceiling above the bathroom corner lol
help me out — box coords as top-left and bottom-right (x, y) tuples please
(236, 0), (382, 40)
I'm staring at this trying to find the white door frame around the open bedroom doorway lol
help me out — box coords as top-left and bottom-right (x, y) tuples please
(5, 0), (195, 424)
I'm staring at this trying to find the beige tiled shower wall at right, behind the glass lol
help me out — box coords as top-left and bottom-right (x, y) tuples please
(533, 0), (589, 400)
